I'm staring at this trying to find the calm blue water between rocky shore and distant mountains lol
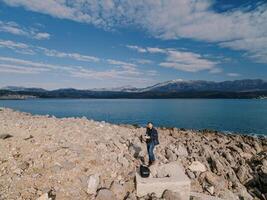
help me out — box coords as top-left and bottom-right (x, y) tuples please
(0, 99), (267, 135)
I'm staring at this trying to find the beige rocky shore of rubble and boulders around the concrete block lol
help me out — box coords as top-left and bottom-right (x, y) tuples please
(0, 108), (267, 200)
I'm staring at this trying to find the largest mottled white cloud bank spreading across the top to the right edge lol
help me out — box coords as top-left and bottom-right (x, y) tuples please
(4, 0), (267, 63)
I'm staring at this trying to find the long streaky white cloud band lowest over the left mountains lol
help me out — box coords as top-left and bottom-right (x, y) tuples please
(0, 56), (156, 84)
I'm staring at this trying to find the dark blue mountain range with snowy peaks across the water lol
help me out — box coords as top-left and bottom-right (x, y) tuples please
(0, 79), (267, 98)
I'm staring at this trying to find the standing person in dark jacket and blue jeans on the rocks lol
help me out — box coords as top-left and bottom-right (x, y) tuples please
(145, 122), (159, 166)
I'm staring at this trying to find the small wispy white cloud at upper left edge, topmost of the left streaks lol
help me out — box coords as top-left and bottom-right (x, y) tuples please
(0, 20), (50, 40)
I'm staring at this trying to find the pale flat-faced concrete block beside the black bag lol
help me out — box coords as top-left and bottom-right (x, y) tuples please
(136, 162), (190, 200)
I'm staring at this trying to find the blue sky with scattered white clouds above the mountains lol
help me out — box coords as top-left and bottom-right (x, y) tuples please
(0, 0), (267, 89)
